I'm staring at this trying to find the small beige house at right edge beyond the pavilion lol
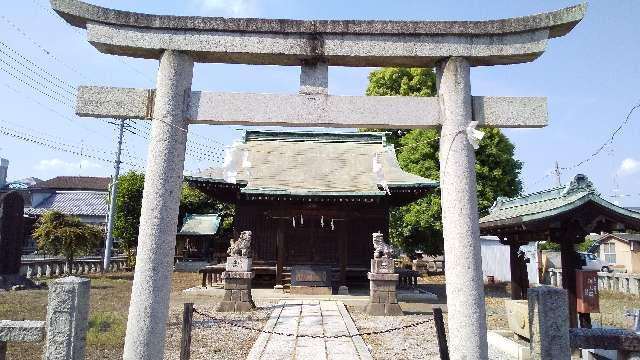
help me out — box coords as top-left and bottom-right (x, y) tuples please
(594, 232), (640, 273)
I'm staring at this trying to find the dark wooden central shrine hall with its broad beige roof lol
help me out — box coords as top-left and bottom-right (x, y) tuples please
(187, 130), (438, 285)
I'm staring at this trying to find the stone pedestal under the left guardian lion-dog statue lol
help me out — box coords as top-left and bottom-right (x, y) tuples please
(218, 271), (256, 312)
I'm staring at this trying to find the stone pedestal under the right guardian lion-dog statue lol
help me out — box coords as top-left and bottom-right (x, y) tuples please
(365, 273), (403, 316)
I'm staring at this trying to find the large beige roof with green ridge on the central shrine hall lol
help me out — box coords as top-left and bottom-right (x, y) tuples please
(193, 131), (438, 195)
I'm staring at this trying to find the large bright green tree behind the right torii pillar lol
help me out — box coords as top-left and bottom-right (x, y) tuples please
(366, 68), (522, 254)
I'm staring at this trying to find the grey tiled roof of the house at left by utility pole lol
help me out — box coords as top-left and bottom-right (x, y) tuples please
(24, 191), (109, 216)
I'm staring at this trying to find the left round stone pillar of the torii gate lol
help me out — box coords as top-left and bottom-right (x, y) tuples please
(123, 50), (193, 360)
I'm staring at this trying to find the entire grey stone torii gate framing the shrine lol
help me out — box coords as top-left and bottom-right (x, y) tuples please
(51, 0), (586, 360)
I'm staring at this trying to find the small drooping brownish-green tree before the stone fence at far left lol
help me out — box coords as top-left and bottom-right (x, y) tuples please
(33, 211), (104, 264)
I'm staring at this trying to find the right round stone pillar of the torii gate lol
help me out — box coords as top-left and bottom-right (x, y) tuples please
(436, 57), (488, 359)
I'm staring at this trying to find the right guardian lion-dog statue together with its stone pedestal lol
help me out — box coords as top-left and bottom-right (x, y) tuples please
(365, 233), (402, 316)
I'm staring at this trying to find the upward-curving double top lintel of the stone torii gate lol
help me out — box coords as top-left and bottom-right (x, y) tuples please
(51, 0), (586, 67)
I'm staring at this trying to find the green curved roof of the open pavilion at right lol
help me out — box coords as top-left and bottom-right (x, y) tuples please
(480, 174), (640, 229)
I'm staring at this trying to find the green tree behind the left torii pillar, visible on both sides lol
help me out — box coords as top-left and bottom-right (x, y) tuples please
(113, 171), (233, 265)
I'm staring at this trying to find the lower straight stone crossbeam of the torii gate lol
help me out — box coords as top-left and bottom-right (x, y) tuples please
(76, 86), (547, 128)
